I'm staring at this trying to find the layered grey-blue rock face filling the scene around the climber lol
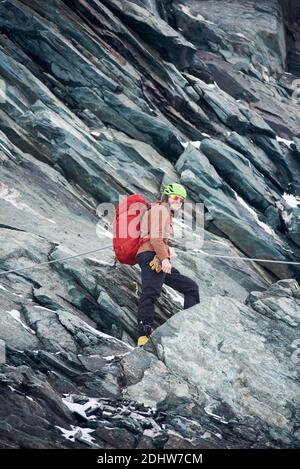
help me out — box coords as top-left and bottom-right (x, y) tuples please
(0, 0), (300, 448)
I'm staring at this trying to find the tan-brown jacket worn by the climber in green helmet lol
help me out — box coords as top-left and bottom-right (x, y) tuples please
(137, 203), (173, 261)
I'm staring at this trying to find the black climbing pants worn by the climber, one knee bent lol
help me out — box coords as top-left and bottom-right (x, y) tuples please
(136, 251), (200, 335)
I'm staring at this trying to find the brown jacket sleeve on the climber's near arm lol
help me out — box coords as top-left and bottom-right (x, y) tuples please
(149, 205), (170, 261)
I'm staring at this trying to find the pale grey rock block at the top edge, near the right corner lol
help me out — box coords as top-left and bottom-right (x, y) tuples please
(175, 0), (286, 71)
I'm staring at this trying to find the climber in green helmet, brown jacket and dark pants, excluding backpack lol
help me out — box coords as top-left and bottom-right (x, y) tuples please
(136, 183), (200, 347)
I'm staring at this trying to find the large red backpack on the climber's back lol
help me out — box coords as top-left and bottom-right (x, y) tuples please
(113, 194), (160, 265)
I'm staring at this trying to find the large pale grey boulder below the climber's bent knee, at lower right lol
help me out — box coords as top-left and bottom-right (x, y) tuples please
(122, 281), (300, 446)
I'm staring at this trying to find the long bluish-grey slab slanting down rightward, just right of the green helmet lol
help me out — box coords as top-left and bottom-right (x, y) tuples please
(176, 145), (300, 278)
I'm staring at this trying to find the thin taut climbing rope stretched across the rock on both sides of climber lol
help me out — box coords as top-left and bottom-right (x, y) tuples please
(0, 244), (300, 276)
